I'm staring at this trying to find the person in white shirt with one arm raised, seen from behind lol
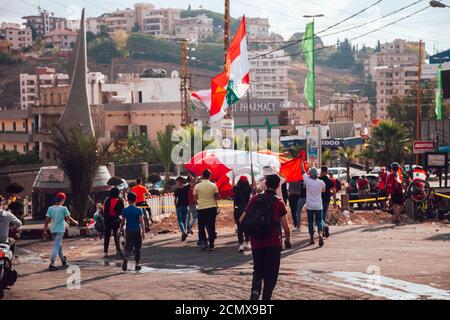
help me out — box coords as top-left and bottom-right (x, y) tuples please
(301, 163), (325, 247)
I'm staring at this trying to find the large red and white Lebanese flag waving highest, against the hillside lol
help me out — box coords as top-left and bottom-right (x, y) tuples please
(210, 16), (250, 121)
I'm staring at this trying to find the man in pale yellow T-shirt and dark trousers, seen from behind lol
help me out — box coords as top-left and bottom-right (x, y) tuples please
(194, 170), (219, 251)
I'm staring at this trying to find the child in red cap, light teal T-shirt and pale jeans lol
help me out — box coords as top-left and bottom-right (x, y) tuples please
(44, 192), (78, 271)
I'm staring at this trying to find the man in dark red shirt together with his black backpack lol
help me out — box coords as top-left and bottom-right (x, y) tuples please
(240, 174), (291, 300)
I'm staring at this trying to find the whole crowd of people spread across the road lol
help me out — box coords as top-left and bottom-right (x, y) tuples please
(0, 163), (434, 300)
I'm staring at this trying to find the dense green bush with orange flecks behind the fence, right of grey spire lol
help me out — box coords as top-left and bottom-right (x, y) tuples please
(110, 135), (157, 164)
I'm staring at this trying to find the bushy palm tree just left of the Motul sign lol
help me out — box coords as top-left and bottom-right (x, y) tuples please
(368, 120), (410, 166)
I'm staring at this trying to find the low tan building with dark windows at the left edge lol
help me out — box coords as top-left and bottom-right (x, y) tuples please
(0, 109), (33, 153)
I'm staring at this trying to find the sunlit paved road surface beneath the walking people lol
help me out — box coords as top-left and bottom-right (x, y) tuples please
(6, 224), (450, 299)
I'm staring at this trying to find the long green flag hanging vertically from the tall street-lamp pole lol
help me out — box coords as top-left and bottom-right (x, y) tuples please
(302, 22), (316, 111)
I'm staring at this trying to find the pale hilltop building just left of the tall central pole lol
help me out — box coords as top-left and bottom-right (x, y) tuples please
(175, 14), (214, 42)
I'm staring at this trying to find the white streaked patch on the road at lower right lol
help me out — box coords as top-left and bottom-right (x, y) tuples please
(297, 271), (450, 300)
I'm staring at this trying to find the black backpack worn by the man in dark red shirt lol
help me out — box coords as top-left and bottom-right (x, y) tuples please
(241, 193), (277, 238)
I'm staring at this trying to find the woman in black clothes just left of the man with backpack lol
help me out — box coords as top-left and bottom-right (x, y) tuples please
(233, 176), (252, 252)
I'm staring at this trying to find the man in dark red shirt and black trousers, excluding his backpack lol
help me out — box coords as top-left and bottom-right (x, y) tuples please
(239, 174), (291, 300)
